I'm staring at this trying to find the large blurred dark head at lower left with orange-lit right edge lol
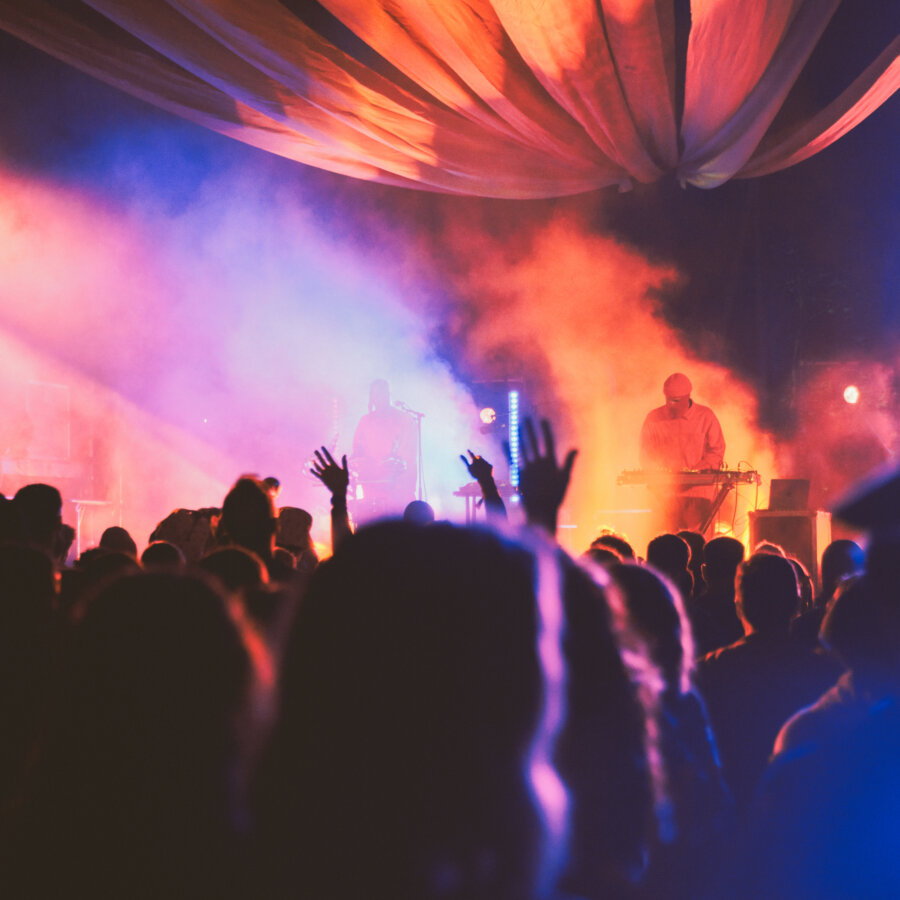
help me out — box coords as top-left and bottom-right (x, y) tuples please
(12, 573), (262, 897)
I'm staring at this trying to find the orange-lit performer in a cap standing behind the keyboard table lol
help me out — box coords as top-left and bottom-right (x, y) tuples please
(641, 372), (725, 531)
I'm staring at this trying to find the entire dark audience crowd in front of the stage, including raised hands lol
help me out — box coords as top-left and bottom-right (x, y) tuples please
(0, 421), (900, 900)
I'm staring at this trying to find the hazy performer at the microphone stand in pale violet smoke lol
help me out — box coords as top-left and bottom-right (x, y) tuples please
(351, 379), (417, 519)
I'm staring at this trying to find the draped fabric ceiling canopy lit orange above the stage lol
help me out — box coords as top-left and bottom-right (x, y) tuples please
(0, 0), (900, 198)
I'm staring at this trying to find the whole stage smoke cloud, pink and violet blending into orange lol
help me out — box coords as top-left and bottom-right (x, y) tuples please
(0, 118), (775, 552)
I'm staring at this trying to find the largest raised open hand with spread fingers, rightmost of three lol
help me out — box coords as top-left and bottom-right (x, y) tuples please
(506, 418), (578, 535)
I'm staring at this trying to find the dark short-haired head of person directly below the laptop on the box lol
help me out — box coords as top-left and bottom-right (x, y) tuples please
(736, 553), (800, 632)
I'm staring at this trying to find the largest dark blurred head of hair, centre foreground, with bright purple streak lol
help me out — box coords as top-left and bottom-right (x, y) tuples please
(258, 521), (651, 900)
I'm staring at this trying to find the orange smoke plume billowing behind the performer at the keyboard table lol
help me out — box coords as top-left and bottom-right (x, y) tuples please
(432, 209), (776, 554)
